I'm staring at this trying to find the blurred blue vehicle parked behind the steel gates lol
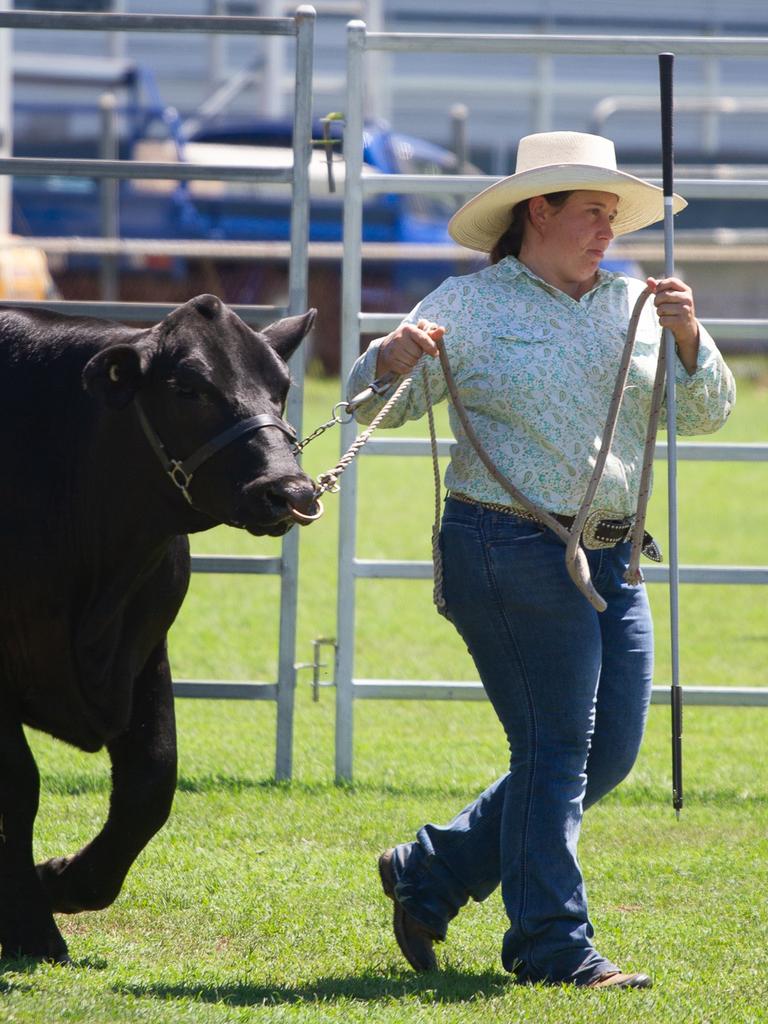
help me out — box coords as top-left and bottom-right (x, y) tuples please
(13, 54), (468, 242)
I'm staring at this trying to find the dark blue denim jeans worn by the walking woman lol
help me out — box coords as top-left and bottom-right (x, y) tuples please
(394, 498), (653, 984)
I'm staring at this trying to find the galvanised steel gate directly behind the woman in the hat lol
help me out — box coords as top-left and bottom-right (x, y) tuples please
(336, 22), (768, 779)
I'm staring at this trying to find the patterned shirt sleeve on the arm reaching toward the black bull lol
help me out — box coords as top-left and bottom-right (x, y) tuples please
(346, 278), (456, 427)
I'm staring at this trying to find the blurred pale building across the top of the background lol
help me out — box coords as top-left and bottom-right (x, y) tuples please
(8, 0), (768, 173)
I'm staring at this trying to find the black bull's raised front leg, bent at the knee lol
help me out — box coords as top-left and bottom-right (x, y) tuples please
(37, 642), (176, 913)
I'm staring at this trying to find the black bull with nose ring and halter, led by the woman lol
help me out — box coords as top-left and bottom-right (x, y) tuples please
(0, 295), (317, 962)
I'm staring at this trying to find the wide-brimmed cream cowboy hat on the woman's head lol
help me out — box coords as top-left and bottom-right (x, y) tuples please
(449, 131), (688, 253)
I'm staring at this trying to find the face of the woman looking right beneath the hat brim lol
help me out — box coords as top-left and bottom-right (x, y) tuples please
(528, 189), (618, 286)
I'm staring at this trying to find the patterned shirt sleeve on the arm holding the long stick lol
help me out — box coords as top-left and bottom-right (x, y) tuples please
(665, 324), (736, 434)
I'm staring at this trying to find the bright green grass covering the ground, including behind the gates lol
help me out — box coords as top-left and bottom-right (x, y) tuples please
(6, 364), (768, 1024)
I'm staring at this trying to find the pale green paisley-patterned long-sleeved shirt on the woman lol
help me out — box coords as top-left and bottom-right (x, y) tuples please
(347, 256), (735, 516)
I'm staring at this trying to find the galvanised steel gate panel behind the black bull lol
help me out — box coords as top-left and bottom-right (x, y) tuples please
(0, 6), (315, 779)
